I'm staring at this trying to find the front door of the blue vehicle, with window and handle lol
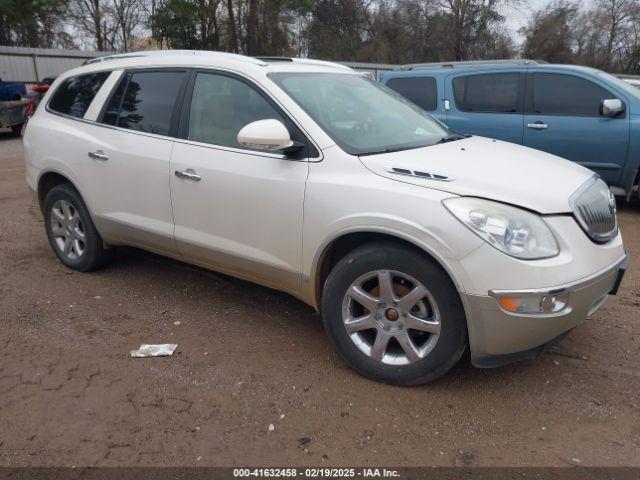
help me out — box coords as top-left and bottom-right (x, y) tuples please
(524, 73), (629, 184)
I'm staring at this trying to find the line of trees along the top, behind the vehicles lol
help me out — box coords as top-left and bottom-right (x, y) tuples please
(0, 0), (640, 73)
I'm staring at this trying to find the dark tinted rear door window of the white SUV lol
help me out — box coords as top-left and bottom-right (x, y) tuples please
(103, 72), (185, 135)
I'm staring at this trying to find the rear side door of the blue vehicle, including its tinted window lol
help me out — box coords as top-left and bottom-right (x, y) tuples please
(445, 72), (524, 143)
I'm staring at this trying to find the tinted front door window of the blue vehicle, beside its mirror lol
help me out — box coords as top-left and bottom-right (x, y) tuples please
(533, 73), (614, 117)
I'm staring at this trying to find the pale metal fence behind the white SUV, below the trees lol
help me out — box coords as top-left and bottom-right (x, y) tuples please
(0, 46), (398, 83)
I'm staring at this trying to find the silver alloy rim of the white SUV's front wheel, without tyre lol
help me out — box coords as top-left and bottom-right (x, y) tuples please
(342, 270), (441, 365)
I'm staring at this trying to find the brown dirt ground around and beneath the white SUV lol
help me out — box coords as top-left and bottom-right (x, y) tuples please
(0, 133), (640, 466)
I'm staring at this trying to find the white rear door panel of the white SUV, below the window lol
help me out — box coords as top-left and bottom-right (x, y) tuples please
(78, 124), (175, 252)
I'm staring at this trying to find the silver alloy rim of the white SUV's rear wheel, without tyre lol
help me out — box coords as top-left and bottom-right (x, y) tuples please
(49, 200), (86, 260)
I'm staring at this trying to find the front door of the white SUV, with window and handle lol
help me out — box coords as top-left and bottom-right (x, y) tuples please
(170, 72), (308, 292)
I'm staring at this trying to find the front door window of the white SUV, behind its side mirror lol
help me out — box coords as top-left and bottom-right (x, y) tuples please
(188, 73), (285, 148)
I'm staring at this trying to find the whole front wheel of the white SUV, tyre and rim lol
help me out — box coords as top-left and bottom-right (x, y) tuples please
(321, 243), (467, 385)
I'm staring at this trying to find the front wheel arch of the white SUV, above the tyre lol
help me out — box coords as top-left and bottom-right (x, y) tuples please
(311, 228), (466, 310)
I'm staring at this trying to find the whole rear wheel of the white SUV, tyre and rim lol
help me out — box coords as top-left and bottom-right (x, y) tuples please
(44, 184), (111, 272)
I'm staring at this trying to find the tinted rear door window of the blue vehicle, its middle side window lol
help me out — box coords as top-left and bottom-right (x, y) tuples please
(453, 73), (520, 113)
